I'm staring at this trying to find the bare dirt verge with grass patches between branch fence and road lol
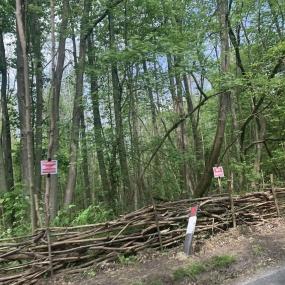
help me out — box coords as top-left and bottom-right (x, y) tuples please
(38, 216), (285, 285)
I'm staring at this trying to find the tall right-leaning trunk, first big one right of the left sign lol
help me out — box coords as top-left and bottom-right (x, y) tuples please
(64, 0), (90, 207)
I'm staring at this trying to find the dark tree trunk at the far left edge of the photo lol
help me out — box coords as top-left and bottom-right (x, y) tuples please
(0, 31), (14, 191)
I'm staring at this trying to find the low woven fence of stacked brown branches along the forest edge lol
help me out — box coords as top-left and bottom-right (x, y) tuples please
(0, 191), (277, 285)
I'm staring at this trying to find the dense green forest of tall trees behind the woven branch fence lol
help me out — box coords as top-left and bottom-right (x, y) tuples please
(0, 0), (285, 237)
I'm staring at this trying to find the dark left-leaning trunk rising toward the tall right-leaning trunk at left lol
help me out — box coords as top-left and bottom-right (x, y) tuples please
(88, 39), (112, 207)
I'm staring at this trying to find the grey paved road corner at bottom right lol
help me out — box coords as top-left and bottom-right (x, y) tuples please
(241, 267), (285, 285)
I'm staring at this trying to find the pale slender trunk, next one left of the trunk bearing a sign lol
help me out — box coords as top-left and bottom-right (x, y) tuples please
(16, 0), (37, 233)
